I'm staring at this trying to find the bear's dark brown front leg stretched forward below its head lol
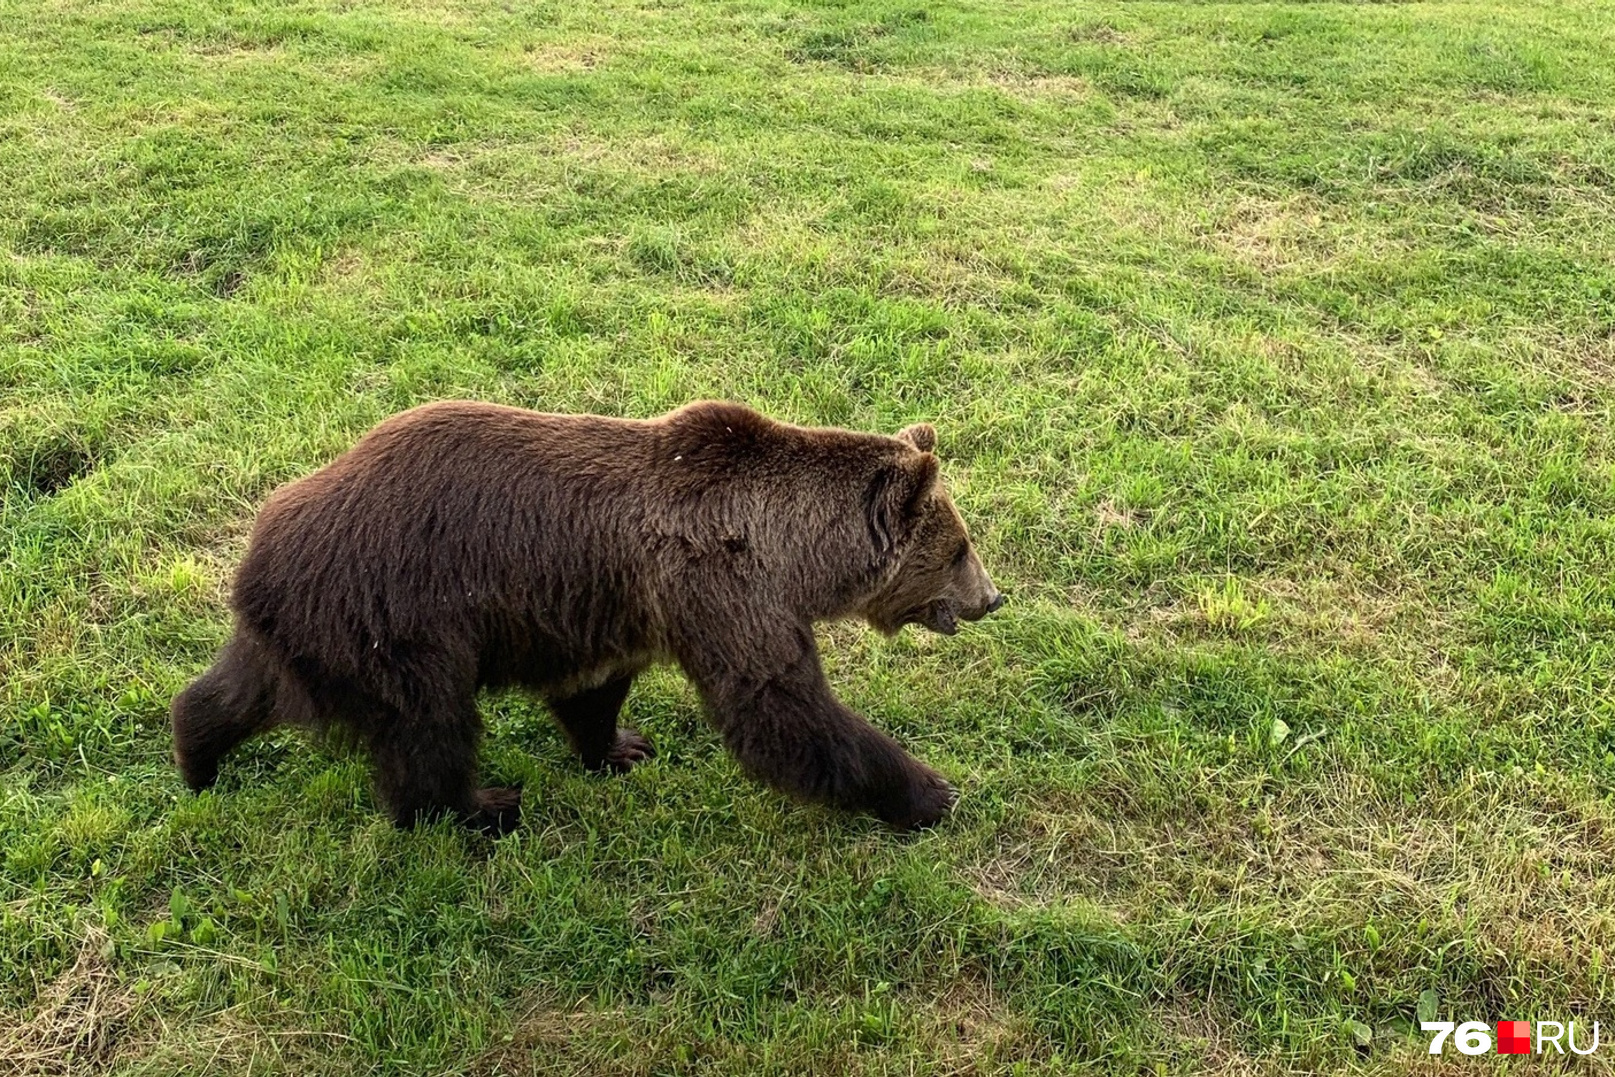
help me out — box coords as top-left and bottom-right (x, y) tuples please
(683, 627), (958, 830)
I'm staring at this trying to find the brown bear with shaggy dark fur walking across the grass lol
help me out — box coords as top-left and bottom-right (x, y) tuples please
(173, 400), (1005, 835)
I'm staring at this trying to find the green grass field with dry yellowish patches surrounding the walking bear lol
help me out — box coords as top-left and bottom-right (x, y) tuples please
(0, 0), (1615, 1077)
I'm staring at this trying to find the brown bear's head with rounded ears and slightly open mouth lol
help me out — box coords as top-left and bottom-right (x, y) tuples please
(861, 423), (1005, 636)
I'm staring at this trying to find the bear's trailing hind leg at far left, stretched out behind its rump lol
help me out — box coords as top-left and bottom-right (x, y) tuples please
(170, 635), (275, 793)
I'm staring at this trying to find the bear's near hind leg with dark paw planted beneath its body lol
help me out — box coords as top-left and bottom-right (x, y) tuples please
(370, 699), (522, 838)
